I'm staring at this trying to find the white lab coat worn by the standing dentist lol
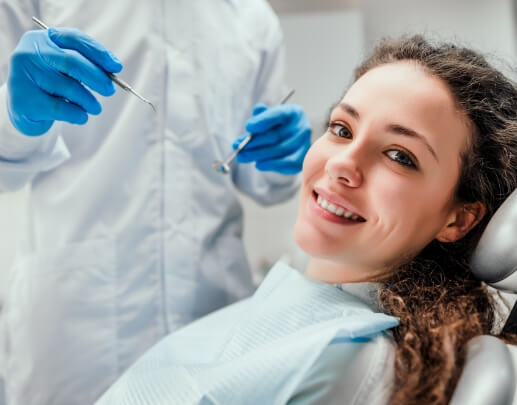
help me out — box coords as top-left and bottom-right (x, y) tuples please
(0, 0), (297, 405)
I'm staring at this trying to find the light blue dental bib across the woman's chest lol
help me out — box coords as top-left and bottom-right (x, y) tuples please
(97, 262), (398, 405)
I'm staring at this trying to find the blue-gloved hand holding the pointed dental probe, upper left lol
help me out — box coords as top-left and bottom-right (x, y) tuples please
(7, 28), (122, 135)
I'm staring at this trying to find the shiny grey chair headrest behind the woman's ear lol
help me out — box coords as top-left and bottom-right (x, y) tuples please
(471, 190), (517, 293)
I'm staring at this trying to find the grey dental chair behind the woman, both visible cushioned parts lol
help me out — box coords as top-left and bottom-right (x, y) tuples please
(451, 190), (517, 405)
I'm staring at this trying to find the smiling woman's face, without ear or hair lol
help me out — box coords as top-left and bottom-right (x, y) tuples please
(295, 62), (471, 282)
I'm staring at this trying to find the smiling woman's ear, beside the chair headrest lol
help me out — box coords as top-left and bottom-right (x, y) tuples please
(436, 201), (486, 242)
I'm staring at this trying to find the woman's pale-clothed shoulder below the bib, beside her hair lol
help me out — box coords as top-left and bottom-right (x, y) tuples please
(289, 333), (395, 405)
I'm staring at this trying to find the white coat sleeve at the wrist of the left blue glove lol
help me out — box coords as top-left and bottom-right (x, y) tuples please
(0, 0), (69, 191)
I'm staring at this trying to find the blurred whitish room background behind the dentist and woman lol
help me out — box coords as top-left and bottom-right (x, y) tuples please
(0, 0), (517, 299)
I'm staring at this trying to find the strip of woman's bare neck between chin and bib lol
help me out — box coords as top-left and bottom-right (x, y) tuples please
(305, 257), (387, 284)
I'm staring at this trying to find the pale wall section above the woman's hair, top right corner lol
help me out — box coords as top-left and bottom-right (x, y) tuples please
(358, 0), (517, 77)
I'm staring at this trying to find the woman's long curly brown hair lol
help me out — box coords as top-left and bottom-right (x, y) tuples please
(355, 36), (517, 405)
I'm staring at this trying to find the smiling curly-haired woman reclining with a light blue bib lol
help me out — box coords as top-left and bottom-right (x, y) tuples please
(93, 36), (517, 405)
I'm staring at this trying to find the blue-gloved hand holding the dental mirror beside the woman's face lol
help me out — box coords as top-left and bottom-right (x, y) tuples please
(232, 104), (311, 174)
